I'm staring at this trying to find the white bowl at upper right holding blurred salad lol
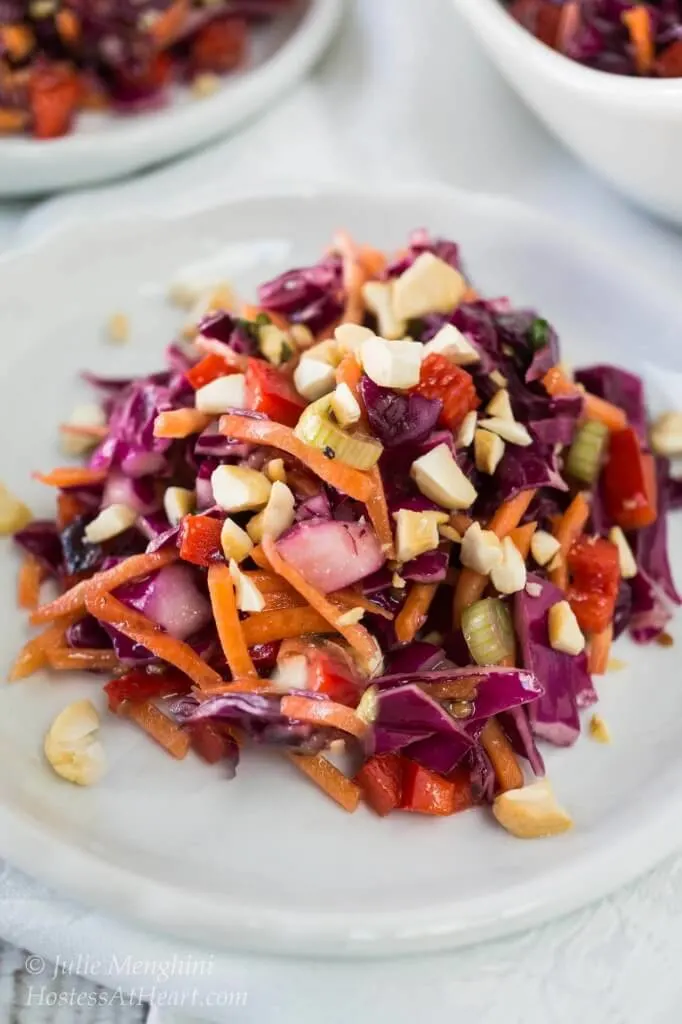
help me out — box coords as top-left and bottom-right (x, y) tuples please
(454, 0), (682, 223)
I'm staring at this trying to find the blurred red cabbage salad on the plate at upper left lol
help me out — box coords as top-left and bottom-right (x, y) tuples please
(0, 0), (288, 138)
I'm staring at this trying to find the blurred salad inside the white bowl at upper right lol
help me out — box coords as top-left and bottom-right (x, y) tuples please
(505, 0), (682, 78)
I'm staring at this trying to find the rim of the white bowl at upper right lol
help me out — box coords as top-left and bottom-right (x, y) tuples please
(453, 0), (682, 110)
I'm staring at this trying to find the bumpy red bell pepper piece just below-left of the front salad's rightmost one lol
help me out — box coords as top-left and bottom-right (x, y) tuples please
(566, 538), (621, 633)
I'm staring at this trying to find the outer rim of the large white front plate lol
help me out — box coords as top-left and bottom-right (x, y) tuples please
(0, 183), (682, 958)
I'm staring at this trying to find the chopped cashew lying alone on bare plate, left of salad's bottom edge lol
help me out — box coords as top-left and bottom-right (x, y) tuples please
(44, 700), (106, 785)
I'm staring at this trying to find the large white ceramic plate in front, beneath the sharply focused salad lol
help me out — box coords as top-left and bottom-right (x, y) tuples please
(0, 186), (682, 955)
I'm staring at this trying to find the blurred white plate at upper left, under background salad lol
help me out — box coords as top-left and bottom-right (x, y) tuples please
(0, 0), (343, 197)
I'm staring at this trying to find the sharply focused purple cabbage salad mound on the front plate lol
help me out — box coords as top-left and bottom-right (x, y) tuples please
(6, 230), (682, 837)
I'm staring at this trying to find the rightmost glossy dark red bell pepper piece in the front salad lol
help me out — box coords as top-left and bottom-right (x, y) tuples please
(602, 427), (657, 529)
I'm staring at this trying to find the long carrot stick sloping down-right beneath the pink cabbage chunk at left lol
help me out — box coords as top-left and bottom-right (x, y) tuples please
(85, 593), (222, 687)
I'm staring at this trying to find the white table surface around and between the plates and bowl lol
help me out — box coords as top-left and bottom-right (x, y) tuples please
(0, 0), (682, 1024)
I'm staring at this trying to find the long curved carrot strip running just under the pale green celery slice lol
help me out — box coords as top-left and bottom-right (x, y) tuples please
(220, 416), (372, 503)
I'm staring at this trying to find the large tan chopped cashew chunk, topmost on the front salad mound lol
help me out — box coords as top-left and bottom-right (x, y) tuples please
(393, 252), (467, 321)
